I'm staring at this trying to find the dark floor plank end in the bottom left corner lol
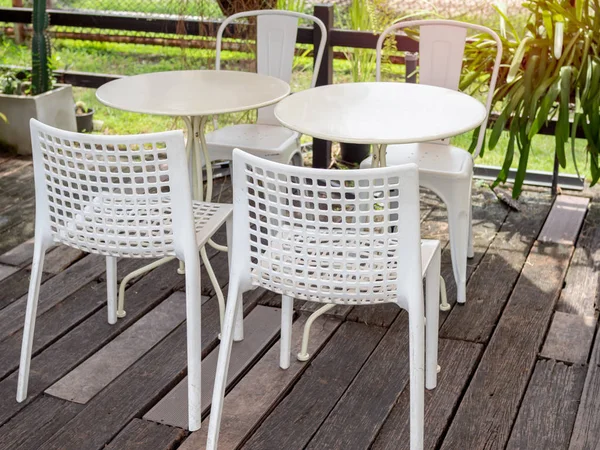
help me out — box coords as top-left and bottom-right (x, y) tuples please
(0, 395), (81, 450)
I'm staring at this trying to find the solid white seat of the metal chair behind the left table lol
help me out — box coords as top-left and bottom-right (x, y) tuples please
(206, 124), (300, 158)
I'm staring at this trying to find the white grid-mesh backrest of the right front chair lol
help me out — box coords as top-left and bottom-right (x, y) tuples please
(231, 149), (421, 304)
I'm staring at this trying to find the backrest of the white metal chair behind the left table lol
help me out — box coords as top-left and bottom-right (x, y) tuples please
(215, 10), (327, 125)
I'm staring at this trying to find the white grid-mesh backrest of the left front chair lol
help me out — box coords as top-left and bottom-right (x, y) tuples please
(30, 119), (195, 258)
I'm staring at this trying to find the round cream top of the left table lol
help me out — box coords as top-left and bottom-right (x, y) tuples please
(96, 70), (290, 116)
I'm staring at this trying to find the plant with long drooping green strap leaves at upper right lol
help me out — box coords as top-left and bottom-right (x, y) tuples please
(462, 0), (600, 198)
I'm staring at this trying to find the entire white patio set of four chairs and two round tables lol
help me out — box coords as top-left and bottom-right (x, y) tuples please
(17, 11), (501, 450)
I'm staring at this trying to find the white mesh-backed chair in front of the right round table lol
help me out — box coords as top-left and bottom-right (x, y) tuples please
(207, 150), (440, 450)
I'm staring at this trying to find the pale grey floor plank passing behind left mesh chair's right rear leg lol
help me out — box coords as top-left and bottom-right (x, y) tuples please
(144, 305), (281, 429)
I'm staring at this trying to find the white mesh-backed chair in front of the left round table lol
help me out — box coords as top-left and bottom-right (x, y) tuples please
(17, 119), (232, 430)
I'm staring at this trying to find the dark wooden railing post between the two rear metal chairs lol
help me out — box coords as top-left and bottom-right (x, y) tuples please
(313, 5), (333, 168)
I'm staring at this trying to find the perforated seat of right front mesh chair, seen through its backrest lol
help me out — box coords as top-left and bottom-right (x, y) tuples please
(252, 234), (440, 305)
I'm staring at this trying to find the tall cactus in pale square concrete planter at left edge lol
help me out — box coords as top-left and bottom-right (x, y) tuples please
(0, 0), (77, 154)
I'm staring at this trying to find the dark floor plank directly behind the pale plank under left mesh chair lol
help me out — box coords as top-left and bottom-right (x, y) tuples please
(0, 261), (188, 423)
